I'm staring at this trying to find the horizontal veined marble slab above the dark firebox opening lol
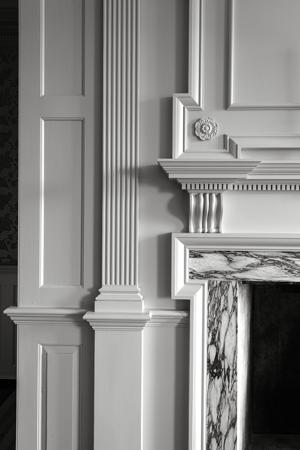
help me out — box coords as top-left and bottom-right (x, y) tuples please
(189, 250), (300, 282)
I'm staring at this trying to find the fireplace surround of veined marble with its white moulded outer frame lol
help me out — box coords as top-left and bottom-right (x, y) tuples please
(172, 233), (300, 450)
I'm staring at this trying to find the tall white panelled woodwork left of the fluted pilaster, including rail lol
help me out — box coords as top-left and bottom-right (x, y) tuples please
(12, 0), (100, 450)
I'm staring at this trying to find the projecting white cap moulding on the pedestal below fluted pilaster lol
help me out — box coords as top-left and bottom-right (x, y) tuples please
(83, 311), (150, 331)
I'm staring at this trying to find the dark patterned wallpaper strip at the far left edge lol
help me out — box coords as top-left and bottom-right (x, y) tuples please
(0, 36), (18, 265)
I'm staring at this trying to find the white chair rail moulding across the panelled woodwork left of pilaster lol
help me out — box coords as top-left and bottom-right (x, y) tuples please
(4, 306), (87, 325)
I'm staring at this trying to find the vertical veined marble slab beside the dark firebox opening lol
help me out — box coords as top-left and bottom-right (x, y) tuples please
(206, 281), (238, 450)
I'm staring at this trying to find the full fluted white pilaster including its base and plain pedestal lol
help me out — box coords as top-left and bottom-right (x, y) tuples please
(84, 0), (146, 450)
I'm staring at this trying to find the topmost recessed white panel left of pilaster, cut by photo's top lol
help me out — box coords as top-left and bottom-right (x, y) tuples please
(41, 0), (84, 95)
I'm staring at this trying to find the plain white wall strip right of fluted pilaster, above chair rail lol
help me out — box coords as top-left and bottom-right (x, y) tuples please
(139, 0), (188, 308)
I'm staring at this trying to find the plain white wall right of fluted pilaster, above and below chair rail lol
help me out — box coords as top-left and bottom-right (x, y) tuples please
(139, 0), (188, 450)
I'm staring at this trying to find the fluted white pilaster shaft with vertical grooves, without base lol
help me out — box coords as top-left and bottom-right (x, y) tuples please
(102, 0), (140, 290)
